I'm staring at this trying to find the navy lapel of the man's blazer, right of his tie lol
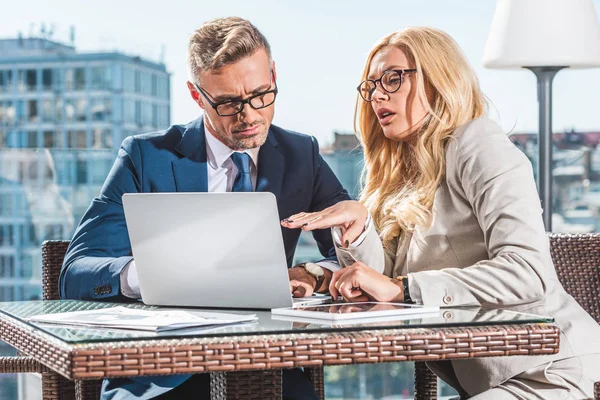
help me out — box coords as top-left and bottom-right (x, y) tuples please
(256, 130), (285, 198)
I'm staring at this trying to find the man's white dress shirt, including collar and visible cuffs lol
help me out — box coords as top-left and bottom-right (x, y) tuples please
(120, 125), (340, 299)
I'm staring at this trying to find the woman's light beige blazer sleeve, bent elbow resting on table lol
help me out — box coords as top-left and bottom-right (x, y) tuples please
(409, 123), (554, 307)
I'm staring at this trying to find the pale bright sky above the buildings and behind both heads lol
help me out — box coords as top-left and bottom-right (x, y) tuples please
(0, 0), (600, 145)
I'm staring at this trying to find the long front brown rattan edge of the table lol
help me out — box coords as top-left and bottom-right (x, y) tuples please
(62, 324), (559, 379)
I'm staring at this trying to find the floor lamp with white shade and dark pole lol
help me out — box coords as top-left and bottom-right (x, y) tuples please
(483, 0), (600, 231)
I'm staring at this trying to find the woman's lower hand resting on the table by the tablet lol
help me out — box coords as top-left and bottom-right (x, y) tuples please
(329, 262), (404, 302)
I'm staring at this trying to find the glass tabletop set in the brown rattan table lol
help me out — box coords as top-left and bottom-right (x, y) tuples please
(0, 300), (554, 344)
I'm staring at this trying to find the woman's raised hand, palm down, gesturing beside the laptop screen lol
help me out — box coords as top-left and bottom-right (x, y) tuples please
(281, 200), (369, 247)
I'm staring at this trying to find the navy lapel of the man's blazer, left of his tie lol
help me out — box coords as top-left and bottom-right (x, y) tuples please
(172, 117), (208, 192)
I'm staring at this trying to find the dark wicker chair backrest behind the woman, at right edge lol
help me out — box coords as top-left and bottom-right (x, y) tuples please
(548, 233), (600, 323)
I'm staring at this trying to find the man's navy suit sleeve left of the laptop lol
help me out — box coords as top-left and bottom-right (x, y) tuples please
(59, 137), (141, 300)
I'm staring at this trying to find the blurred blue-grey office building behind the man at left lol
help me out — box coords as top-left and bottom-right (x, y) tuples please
(0, 37), (170, 301)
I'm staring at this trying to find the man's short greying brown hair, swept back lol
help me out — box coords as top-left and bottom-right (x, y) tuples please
(188, 17), (271, 79)
